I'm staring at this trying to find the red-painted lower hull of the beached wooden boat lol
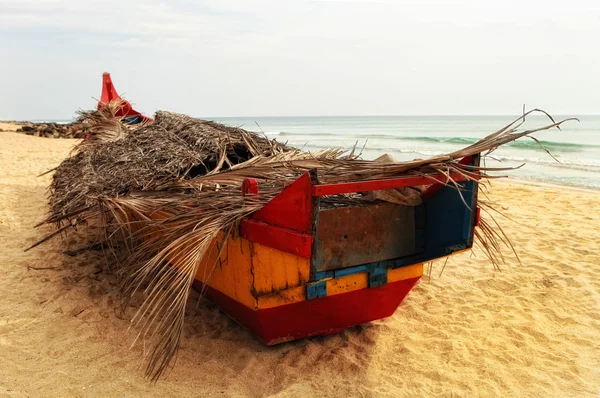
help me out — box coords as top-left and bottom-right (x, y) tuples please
(194, 277), (420, 345)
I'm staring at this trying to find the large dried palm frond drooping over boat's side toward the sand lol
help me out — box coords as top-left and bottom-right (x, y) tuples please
(103, 189), (279, 380)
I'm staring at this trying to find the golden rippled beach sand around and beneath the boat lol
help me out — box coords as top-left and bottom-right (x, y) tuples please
(0, 127), (600, 397)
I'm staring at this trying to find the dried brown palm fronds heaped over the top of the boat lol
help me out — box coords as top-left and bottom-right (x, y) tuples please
(32, 104), (576, 380)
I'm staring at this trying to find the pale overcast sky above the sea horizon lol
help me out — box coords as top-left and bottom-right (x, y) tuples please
(0, 0), (600, 120)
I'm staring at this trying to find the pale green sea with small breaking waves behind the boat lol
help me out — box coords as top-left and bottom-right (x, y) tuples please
(207, 115), (600, 188)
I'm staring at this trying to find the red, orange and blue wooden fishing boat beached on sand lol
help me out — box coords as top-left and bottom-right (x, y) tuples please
(99, 74), (479, 345)
